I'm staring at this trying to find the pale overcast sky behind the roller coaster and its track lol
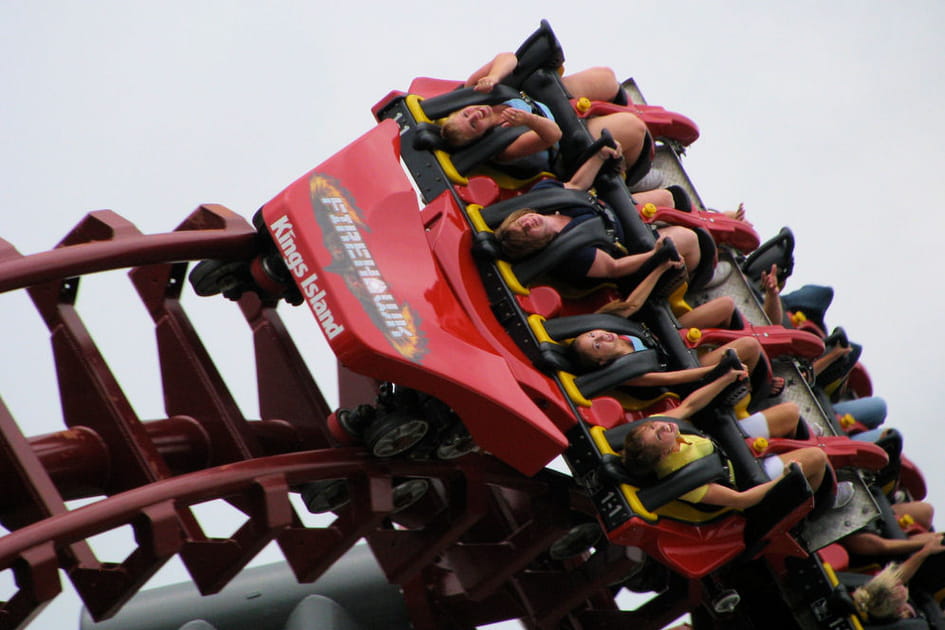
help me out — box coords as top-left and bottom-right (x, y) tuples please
(0, 0), (945, 627)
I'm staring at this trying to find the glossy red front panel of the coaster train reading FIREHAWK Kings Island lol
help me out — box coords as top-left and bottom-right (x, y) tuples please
(262, 121), (567, 475)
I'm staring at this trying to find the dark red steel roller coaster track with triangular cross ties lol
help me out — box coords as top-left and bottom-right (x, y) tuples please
(0, 205), (700, 630)
